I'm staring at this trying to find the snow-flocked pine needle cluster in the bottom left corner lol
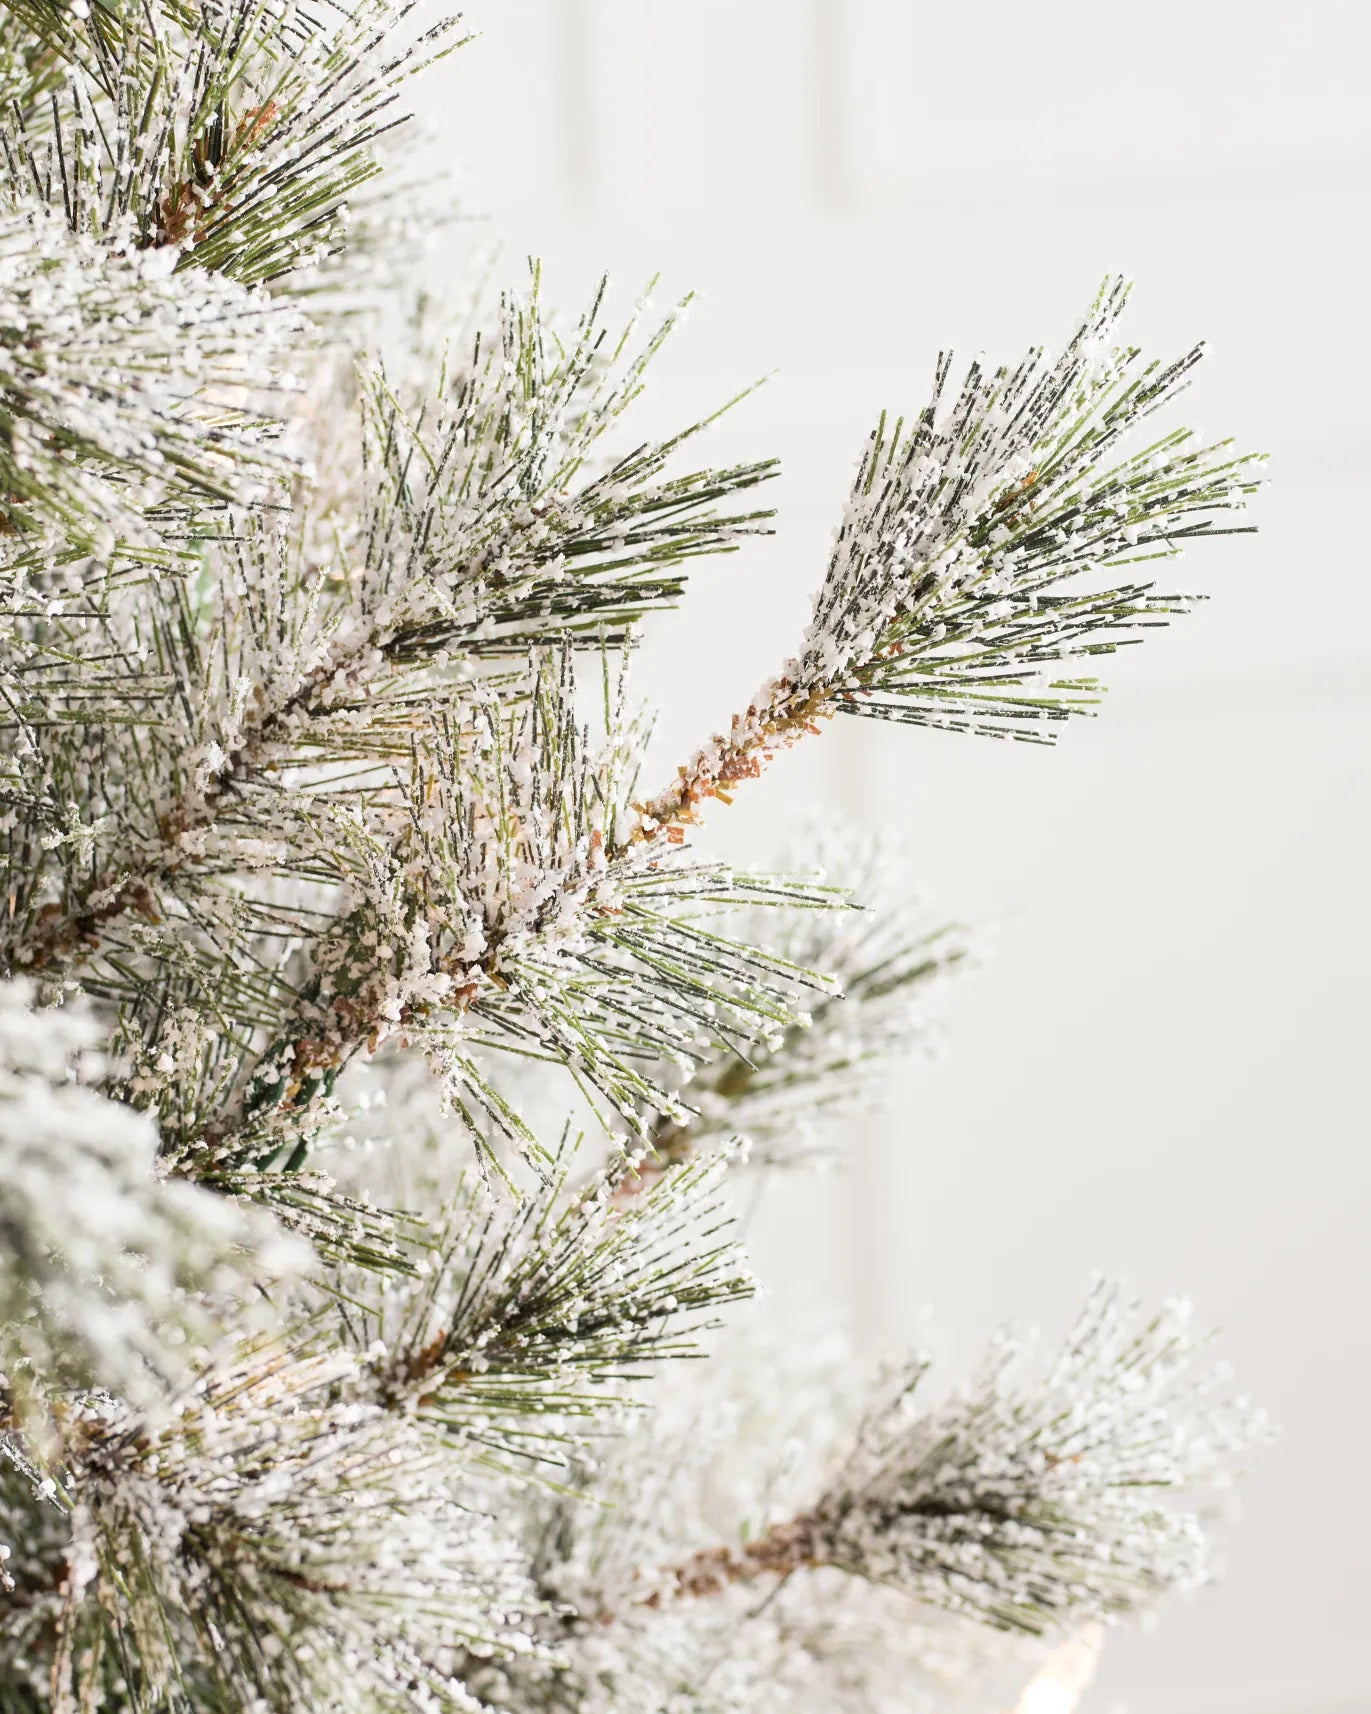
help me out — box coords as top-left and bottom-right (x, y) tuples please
(0, 1345), (538, 1714)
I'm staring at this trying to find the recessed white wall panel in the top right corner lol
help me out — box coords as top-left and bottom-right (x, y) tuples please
(824, 0), (1371, 206)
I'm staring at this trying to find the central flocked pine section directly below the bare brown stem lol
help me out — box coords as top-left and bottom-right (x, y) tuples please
(185, 653), (843, 1172)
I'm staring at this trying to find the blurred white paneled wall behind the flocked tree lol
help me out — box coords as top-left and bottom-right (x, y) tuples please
(422, 0), (1371, 1714)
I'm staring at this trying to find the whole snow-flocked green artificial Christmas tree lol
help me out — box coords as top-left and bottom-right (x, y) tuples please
(0, 0), (1256, 1714)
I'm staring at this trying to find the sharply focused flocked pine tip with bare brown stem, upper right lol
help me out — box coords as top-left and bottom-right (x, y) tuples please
(641, 281), (1258, 836)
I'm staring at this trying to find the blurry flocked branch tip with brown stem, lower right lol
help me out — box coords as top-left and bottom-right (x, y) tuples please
(603, 1287), (1261, 1633)
